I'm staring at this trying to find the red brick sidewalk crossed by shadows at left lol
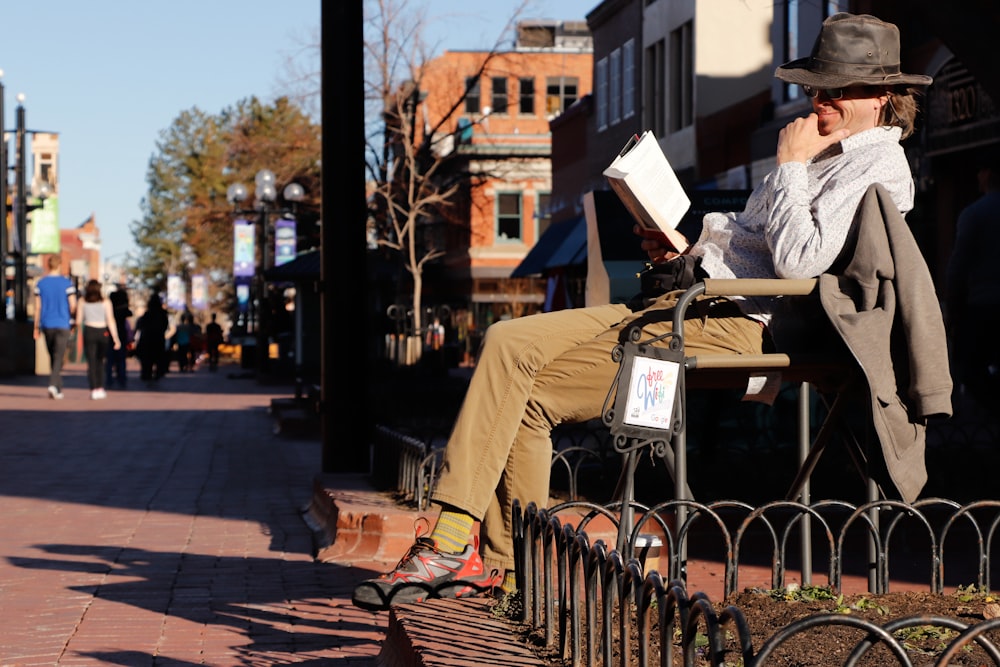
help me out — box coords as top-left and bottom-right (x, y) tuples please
(0, 365), (398, 667)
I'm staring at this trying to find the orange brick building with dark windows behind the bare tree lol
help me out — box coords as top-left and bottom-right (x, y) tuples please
(406, 21), (593, 325)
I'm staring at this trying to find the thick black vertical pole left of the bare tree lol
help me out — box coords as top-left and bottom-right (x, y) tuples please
(320, 0), (374, 472)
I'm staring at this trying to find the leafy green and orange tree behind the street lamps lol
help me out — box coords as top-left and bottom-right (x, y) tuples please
(131, 98), (321, 318)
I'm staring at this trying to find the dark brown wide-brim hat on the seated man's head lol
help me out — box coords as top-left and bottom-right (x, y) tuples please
(774, 12), (933, 88)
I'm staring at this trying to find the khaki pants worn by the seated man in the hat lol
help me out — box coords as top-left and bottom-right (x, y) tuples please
(433, 293), (764, 572)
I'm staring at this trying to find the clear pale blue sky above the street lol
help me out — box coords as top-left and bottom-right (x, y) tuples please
(0, 0), (584, 263)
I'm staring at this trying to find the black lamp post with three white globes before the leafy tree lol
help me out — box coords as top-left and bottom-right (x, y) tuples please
(226, 169), (305, 372)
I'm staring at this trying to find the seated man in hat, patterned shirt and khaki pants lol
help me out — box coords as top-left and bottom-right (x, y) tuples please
(353, 14), (931, 609)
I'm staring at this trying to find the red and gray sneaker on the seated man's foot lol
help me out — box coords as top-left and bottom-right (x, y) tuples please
(351, 530), (503, 611)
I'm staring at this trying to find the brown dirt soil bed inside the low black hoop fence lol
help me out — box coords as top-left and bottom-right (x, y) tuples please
(511, 588), (1000, 667)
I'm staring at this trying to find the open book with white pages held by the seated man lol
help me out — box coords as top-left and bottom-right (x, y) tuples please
(604, 130), (691, 252)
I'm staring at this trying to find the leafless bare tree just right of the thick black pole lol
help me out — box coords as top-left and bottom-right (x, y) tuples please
(365, 0), (530, 360)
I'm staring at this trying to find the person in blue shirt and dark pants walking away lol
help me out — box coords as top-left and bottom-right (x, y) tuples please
(34, 255), (76, 399)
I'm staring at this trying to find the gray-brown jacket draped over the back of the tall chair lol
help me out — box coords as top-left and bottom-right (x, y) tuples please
(819, 184), (952, 502)
